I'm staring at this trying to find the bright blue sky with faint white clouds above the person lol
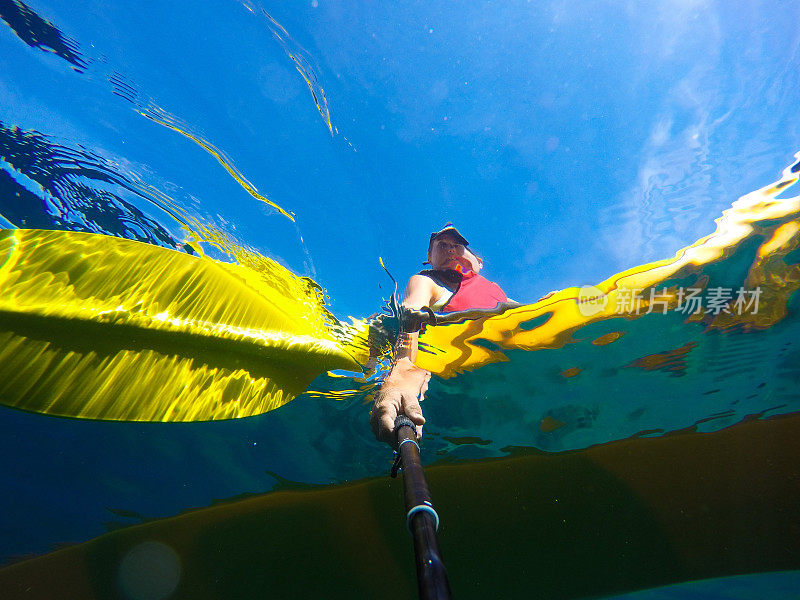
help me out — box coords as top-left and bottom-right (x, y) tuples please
(0, 0), (800, 316)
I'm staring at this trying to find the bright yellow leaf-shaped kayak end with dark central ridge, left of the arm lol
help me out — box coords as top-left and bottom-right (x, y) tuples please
(0, 230), (358, 421)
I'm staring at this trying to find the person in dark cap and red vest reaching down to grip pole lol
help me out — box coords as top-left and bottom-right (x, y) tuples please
(370, 223), (508, 445)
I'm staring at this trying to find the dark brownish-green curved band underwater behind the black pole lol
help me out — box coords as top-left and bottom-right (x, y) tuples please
(0, 415), (800, 600)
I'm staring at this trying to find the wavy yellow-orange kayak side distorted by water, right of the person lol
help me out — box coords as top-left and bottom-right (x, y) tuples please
(416, 155), (800, 377)
